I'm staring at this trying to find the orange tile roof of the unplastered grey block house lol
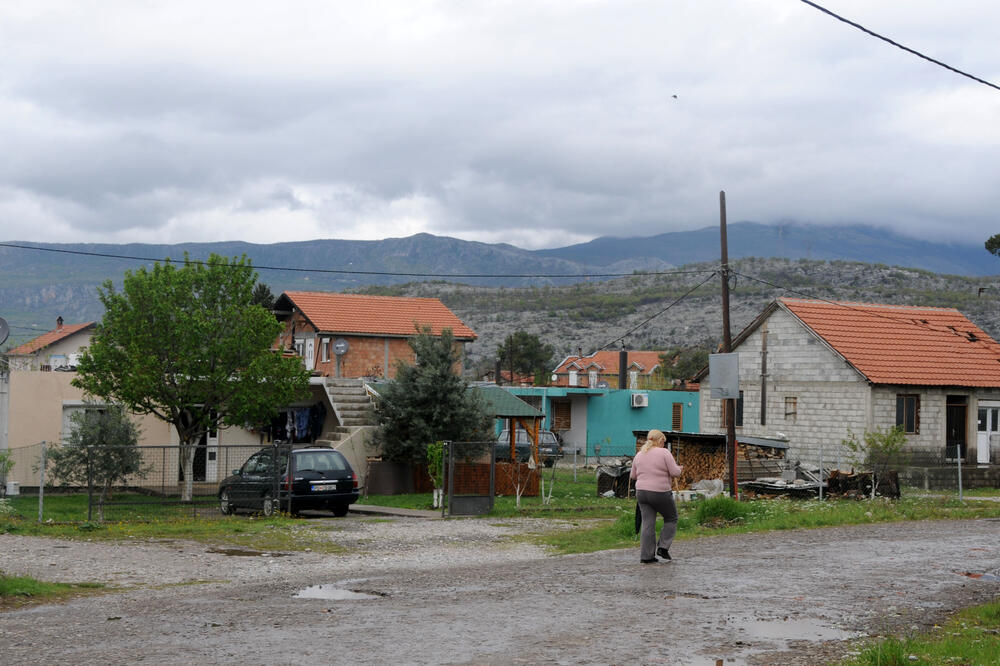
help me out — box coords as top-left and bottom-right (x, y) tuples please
(778, 298), (1000, 387)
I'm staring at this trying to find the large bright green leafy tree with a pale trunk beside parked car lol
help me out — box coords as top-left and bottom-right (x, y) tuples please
(73, 254), (309, 500)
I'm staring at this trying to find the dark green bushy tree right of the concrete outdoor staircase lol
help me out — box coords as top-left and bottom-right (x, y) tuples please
(376, 328), (493, 463)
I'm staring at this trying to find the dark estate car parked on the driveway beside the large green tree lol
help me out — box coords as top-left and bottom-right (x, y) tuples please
(219, 446), (358, 516)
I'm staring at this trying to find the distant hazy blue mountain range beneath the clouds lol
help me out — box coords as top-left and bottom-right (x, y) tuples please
(0, 222), (1000, 356)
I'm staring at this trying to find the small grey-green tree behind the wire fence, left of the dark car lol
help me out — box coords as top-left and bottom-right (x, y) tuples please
(48, 404), (149, 521)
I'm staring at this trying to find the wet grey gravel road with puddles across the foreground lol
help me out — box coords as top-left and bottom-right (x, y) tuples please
(0, 514), (1000, 666)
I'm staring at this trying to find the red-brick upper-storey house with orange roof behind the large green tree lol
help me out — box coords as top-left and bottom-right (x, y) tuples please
(274, 291), (476, 378)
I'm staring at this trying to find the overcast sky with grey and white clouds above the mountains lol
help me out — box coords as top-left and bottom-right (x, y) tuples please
(0, 0), (1000, 249)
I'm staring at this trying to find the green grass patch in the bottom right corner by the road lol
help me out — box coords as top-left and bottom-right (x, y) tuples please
(841, 600), (1000, 666)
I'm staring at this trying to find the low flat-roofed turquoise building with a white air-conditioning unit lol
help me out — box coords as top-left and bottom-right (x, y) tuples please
(498, 386), (699, 458)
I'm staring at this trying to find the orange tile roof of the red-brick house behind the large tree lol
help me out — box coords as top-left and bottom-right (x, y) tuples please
(279, 291), (477, 340)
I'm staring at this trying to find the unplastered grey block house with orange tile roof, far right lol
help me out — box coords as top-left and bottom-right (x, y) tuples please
(696, 298), (1000, 468)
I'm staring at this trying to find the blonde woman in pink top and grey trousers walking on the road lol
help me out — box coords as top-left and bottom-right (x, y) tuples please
(630, 430), (684, 564)
